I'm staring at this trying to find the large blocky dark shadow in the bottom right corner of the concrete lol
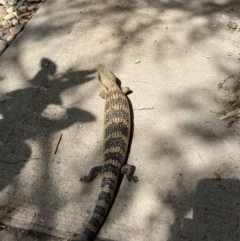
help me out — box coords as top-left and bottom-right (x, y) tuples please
(165, 179), (240, 241)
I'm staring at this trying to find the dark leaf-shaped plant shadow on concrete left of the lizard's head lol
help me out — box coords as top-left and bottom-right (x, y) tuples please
(0, 58), (95, 158)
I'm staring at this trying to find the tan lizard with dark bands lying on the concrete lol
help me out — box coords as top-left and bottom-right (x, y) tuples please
(80, 65), (138, 241)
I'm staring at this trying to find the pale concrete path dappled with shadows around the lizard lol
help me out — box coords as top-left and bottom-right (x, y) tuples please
(0, 0), (240, 241)
